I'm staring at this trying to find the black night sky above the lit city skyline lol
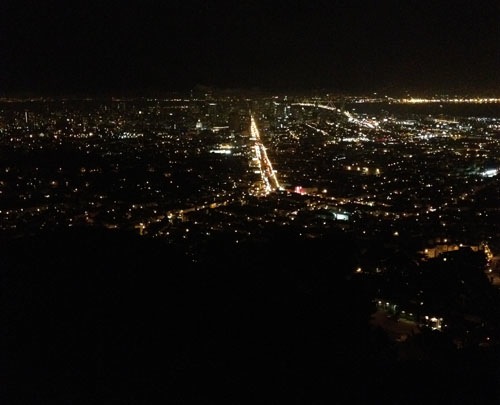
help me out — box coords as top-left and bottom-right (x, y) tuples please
(0, 0), (500, 95)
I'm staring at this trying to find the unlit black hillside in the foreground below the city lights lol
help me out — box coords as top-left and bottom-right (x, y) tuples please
(0, 230), (500, 405)
